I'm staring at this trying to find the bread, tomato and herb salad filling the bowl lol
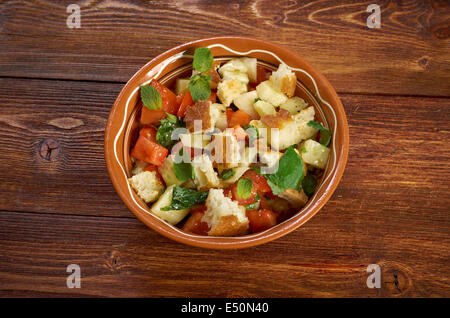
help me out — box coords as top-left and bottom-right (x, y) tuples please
(128, 48), (332, 236)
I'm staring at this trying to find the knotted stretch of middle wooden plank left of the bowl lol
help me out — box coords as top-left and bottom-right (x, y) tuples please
(0, 79), (128, 217)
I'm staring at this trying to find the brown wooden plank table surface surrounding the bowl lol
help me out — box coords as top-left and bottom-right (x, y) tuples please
(0, 0), (450, 297)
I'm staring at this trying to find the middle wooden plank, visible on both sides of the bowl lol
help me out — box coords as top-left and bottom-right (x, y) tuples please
(0, 79), (450, 226)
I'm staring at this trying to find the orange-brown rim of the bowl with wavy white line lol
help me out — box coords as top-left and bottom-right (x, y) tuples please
(104, 36), (349, 249)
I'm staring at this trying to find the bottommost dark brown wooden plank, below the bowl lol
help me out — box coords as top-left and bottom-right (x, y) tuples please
(0, 209), (450, 297)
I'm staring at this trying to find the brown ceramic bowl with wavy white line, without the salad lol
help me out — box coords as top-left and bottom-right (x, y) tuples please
(105, 37), (349, 249)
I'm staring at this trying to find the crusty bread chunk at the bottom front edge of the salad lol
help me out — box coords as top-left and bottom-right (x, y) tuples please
(202, 189), (248, 236)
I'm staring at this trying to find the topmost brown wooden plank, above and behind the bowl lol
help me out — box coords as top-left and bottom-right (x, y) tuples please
(0, 0), (450, 96)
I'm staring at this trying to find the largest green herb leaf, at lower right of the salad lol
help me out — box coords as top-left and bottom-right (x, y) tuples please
(264, 146), (304, 195)
